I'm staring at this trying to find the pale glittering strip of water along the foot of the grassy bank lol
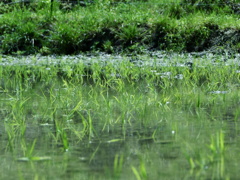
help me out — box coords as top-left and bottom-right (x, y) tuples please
(0, 51), (240, 67)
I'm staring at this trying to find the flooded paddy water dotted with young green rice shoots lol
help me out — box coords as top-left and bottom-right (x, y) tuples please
(0, 52), (240, 180)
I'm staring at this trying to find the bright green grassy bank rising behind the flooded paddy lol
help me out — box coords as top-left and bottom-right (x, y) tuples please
(0, 0), (240, 54)
